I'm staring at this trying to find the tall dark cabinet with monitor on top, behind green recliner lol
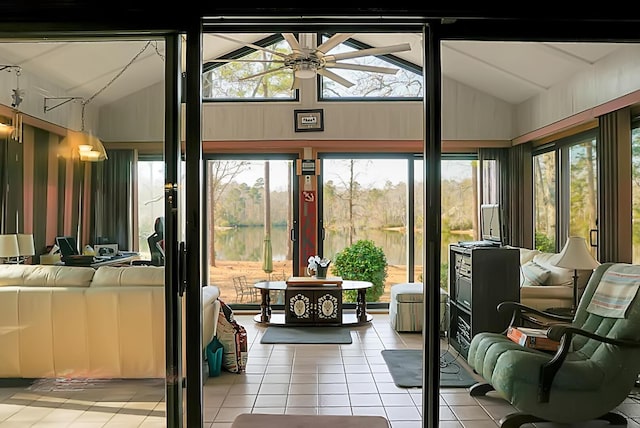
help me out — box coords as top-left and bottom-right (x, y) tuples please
(449, 245), (520, 359)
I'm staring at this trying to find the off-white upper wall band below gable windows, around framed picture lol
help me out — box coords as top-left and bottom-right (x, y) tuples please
(98, 79), (513, 142)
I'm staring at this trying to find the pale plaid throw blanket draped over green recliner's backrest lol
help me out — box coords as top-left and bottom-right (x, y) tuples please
(587, 263), (640, 318)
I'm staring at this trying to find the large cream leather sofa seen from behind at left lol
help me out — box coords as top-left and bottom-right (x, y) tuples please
(0, 264), (220, 378)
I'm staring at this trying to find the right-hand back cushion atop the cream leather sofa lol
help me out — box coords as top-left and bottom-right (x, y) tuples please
(91, 266), (164, 287)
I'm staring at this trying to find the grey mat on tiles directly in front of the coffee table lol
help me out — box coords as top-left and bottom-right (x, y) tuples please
(260, 326), (352, 345)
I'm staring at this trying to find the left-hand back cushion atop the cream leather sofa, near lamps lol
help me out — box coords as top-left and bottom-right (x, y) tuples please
(0, 264), (95, 287)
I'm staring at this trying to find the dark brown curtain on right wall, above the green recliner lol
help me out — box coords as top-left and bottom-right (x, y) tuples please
(597, 108), (632, 263)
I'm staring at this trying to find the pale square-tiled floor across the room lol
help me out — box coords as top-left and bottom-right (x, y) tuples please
(0, 314), (640, 428)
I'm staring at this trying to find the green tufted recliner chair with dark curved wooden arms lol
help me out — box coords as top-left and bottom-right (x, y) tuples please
(468, 263), (640, 428)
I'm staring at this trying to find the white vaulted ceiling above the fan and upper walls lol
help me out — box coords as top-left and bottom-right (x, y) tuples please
(0, 34), (621, 109)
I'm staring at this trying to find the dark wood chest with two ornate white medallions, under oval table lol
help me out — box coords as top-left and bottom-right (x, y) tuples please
(285, 286), (342, 325)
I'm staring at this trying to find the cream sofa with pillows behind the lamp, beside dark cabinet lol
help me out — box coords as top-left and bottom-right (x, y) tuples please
(519, 248), (593, 310)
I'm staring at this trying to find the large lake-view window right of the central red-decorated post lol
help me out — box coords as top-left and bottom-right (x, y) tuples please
(321, 155), (478, 303)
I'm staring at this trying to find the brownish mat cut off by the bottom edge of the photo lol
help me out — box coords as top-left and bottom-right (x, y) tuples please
(231, 413), (389, 428)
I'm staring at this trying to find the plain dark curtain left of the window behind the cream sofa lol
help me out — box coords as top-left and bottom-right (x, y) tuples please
(90, 150), (135, 251)
